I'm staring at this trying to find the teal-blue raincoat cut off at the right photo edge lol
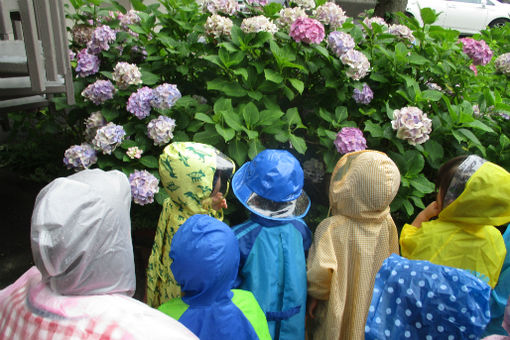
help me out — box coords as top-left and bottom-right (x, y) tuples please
(484, 225), (510, 336)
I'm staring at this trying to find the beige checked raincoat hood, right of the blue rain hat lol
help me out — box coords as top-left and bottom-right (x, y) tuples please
(329, 150), (400, 219)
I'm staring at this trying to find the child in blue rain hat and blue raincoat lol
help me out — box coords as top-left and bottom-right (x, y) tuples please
(232, 149), (311, 340)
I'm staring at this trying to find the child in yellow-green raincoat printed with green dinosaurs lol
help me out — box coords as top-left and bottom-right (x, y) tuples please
(146, 142), (235, 307)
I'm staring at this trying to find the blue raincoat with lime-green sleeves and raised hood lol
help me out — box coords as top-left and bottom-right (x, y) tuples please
(158, 215), (270, 340)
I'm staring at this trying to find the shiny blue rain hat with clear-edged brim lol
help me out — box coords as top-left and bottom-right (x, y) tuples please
(232, 149), (310, 220)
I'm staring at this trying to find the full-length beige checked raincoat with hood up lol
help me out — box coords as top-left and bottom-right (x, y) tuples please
(307, 150), (400, 340)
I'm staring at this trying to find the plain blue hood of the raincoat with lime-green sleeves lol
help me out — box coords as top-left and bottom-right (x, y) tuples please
(170, 215), (239, 306)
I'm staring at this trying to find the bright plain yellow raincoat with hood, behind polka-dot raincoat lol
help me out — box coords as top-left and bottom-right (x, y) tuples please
(400, 162), (510, 288)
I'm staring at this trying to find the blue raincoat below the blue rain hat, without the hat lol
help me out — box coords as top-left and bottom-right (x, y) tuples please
(234, 214), (312, 340)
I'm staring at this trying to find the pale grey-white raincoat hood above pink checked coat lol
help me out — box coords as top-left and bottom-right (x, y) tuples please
(30, 169), (136, 296)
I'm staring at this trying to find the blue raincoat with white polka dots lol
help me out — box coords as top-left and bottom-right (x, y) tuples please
(365, 254), (490, 340)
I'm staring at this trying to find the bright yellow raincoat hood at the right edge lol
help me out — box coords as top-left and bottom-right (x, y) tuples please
(439, 162), (510, 226)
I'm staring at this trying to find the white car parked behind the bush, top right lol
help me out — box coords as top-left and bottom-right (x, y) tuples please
(407, 0), (510, 34)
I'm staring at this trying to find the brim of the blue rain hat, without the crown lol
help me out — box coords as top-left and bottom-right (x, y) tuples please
(232, 162), (311, 221)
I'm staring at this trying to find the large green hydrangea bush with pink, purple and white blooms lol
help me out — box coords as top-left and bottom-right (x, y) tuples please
(64, 0), (510, 220)
